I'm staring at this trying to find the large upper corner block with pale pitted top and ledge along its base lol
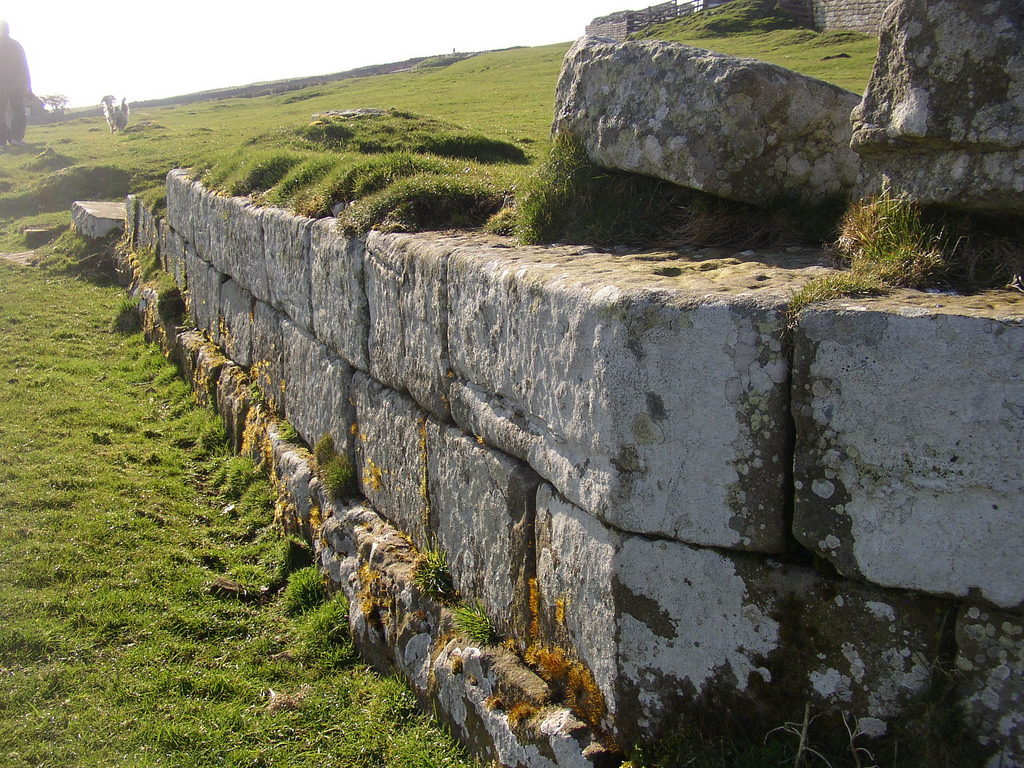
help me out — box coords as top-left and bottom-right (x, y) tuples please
(447, 239), (800, 552)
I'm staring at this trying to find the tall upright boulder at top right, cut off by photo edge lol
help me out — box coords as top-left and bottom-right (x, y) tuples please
(852, 0), (1024, 215)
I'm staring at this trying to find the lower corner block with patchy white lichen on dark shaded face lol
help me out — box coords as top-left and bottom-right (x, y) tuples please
(537, 485), (950, 743)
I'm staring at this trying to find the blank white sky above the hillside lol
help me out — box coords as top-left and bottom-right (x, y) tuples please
(0, 0), (630, 106)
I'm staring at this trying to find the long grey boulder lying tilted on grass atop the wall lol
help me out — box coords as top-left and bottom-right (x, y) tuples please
(552, 38), (860, 206)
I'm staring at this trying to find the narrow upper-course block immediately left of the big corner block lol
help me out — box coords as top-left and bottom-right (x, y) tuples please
(366, 232), (456, 421)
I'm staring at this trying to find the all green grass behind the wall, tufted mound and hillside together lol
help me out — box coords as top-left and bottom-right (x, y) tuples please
(0, 21), (877, 251)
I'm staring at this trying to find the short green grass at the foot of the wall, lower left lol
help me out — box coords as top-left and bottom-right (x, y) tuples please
(0, 257), (471, 768)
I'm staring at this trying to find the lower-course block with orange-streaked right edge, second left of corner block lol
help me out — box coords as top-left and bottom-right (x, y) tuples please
(352, 373), (429, 545)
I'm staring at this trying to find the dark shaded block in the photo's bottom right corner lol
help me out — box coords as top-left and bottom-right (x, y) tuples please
(956, 606), (1024, 767)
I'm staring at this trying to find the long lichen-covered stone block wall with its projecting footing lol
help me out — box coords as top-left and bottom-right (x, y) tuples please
(119, 172), (1024, 766)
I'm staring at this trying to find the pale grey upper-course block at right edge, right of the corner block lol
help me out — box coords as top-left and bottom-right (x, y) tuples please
(794, 293), (1024, 608)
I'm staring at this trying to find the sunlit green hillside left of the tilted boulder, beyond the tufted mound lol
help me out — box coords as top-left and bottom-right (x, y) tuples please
(0, 43), (568, 251)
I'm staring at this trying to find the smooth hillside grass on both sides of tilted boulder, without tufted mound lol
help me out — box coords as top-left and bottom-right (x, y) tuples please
(0, 12), (877, 251)
